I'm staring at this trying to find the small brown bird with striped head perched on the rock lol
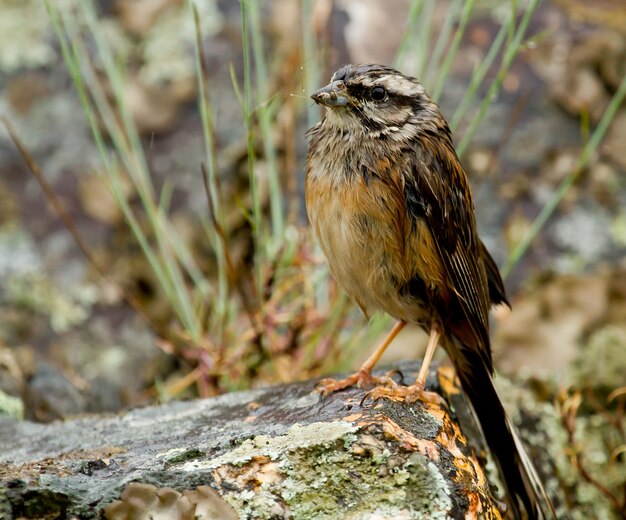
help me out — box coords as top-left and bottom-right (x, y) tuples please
(305, 64), (555, 519)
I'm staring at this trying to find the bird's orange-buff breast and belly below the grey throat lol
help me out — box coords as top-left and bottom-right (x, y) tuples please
(306, 165), (434, 321)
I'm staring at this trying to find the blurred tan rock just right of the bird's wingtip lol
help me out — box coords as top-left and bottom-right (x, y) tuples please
(493, 268), (626, 385)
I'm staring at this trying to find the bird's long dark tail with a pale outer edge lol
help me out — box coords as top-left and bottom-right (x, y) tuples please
(446, 338), (556, 520)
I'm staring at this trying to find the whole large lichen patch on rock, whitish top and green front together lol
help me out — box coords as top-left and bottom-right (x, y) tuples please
(193, 421), (452, 520)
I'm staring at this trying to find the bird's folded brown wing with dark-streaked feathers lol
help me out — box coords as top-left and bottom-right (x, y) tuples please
(404, 135), (492, 369)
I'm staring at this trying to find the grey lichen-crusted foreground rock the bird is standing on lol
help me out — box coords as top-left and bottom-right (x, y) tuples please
(0, 367), (520, 519)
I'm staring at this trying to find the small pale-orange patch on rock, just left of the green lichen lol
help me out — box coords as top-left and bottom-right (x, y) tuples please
(213, 455), (284, 491)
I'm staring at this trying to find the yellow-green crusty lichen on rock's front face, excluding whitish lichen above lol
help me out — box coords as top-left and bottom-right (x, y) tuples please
(282, 449), (451, 519)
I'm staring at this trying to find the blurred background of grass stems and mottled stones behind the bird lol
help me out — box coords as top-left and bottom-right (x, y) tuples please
(0, 0), (626, 430)
